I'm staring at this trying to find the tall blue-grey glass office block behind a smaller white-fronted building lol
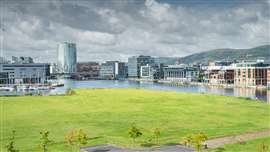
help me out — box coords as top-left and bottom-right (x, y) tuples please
(128, 55), (154, 78)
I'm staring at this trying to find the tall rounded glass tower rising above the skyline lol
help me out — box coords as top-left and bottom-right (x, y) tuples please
(57, 42), (77, 74)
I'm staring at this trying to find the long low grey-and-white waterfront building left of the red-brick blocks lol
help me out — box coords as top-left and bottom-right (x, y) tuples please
(163, 65), (199, 82)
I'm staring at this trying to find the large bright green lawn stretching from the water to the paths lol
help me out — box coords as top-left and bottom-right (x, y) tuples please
(0, 89), (270, 152)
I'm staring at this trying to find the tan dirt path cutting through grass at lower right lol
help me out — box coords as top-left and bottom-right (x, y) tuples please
(205, 129), (270, 149)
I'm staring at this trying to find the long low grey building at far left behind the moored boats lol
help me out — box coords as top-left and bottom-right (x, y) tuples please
(0, 63), (50, 84)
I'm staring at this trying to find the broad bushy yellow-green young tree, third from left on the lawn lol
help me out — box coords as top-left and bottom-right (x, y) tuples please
(65, 129), (88, 151)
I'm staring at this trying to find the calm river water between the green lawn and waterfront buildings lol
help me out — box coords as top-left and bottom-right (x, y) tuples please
(0, 80), (270, 102)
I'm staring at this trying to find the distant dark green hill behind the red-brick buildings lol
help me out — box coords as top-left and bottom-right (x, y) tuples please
(180, 45), (270, 64)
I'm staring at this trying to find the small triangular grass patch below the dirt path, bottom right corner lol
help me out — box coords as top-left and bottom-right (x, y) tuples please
(209, 137), (270, 152)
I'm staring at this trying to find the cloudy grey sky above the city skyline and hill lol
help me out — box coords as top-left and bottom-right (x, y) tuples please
(0, 0), (270, 62)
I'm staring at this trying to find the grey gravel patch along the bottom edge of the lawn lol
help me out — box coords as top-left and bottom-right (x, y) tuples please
(81, 145), (195, 152)
